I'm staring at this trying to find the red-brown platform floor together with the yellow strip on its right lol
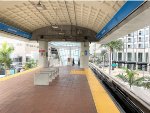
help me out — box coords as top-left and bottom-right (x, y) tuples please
(0, 66), (119, 113)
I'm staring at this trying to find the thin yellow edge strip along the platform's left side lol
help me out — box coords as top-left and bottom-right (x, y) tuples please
(0, 67), (41, 81)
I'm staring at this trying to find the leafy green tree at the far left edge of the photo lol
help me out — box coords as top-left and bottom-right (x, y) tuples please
(0, 42), (14, 76)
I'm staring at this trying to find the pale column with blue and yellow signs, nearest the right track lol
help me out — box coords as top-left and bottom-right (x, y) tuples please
(80, 42), (89, 68)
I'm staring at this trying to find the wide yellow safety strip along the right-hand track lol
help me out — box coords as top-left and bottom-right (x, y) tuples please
(85, 68), (120, 113)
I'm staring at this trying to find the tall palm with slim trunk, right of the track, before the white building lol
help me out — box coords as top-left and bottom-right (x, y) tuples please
(102, 40), (123, 74)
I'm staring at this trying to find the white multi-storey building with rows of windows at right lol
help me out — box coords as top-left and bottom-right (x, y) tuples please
(113, 26), (150, 70)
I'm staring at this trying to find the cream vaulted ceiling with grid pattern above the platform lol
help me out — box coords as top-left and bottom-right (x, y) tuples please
(0, 0), (125, 41)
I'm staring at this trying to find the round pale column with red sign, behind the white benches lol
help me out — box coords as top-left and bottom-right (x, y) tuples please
(38, 41), (49, 67)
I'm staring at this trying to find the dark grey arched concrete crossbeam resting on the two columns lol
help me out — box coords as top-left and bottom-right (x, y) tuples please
(32, 25), (98, 42)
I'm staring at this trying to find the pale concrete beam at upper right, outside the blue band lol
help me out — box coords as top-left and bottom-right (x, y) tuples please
(100, 1), (150, 43)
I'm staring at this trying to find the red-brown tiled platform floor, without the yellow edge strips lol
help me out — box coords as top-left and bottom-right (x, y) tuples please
(0, 67), (96, 113)
